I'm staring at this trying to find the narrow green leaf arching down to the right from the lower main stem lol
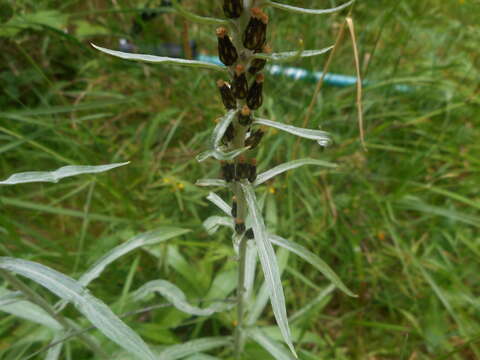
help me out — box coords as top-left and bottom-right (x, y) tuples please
(269, 235), (357, 297)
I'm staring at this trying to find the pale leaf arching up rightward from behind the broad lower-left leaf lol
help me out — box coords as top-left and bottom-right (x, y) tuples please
(78, 227), (190, 286)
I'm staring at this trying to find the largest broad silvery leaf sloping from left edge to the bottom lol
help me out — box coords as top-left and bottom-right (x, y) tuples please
(0, 257), (156, 360)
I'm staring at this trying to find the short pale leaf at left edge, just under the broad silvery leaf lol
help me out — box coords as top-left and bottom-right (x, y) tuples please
(0, 289), (62, 330)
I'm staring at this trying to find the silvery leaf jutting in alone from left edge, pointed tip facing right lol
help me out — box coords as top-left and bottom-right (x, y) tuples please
(0, 162), (129, 185)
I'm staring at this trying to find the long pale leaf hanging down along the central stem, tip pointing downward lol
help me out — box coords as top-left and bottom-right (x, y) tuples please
(241, 181), (298, 357)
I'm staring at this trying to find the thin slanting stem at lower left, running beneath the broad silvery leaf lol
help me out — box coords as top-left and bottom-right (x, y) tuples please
(0, 269), (109, 359)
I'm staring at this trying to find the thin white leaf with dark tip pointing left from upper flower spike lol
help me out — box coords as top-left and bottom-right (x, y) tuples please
(90, 44), (226, 72)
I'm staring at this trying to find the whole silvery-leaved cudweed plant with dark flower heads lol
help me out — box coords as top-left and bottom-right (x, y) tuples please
(0, 0), (354, 359)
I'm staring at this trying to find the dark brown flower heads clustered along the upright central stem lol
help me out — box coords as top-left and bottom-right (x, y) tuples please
(216, 0), (270, 238)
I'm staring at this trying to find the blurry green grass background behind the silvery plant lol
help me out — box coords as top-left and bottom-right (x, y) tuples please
(0, 0), (480, 360)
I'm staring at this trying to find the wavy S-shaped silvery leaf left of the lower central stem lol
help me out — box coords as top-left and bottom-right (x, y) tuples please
(132, 280), (229, 316)
